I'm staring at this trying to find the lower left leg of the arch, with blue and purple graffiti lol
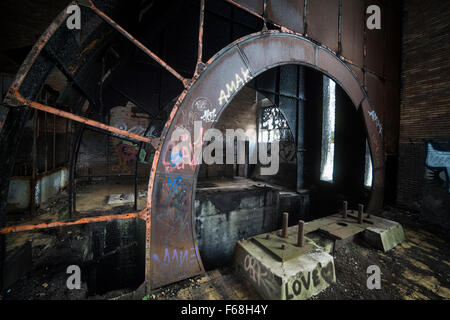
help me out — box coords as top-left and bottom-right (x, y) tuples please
(150, 173), (204, 288)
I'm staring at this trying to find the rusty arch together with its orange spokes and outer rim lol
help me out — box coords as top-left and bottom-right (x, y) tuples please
(0, 0), (384, 292)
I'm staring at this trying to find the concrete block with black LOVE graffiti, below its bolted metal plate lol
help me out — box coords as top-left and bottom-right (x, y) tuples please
(234, 239), (336, 300)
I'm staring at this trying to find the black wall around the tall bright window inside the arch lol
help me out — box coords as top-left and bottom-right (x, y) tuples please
(305, 68), (369, 218)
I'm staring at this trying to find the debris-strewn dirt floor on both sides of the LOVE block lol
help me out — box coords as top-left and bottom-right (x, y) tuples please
(0, 210), (450, 300)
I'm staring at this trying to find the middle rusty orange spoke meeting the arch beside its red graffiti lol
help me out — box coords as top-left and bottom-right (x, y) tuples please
(7, 90), (159, 149)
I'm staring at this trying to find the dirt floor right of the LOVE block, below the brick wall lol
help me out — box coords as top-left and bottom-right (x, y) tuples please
(313, 210), (450, 300)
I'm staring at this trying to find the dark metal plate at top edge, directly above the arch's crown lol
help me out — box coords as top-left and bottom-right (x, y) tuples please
(267, 0), (305, 33)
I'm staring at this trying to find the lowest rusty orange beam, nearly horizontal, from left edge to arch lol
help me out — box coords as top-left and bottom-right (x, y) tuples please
(0, 212), (142, 234)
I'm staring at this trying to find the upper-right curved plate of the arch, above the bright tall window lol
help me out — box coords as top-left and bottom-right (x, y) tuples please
(317, 49), (364, 108)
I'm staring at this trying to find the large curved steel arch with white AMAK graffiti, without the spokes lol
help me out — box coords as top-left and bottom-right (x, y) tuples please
(146, 30), (384, 288)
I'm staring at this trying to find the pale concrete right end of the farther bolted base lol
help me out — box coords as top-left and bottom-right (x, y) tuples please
(363, 217), (405, 252)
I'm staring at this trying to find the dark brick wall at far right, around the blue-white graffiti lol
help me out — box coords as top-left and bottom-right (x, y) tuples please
(397, 0), (450, 226)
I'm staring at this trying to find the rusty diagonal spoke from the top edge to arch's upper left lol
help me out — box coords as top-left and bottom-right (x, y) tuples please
(80, 0), (190, 88)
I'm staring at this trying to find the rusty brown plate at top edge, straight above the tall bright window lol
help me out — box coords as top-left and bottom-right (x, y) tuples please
(306, 0), (339, 52)
